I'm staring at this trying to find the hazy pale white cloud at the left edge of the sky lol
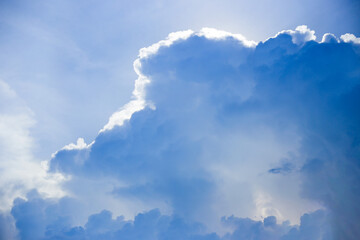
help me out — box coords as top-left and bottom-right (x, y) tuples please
(0, 81), (64, 211)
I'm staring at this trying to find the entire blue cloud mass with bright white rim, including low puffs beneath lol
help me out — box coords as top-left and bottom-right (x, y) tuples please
(0, 26), (360, 240)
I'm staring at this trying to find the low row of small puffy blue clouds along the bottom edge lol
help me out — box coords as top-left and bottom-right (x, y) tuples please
(7, 192), (331, 240)
